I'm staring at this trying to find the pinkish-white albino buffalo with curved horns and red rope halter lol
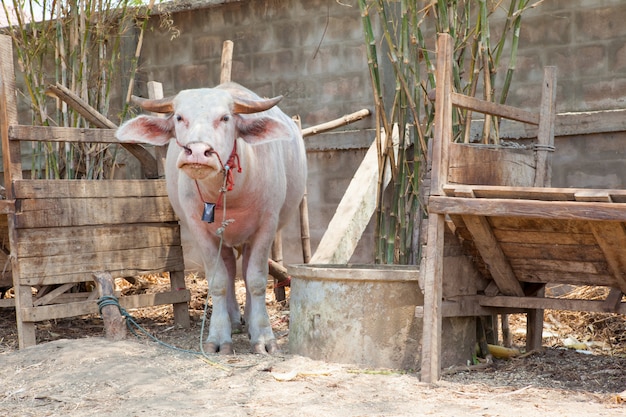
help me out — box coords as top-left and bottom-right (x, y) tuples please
(116, 83), (306, 353)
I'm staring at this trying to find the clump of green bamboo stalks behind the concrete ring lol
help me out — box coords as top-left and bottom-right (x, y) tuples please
(358, 0), (528, 263)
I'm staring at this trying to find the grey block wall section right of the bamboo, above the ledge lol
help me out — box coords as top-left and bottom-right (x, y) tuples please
(503, 0), (626, 112)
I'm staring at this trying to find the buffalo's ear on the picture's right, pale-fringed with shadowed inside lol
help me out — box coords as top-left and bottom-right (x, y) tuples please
(237, 116), (299, 145)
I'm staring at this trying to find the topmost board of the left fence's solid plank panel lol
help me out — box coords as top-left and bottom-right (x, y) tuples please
(13, 179), (167, 199)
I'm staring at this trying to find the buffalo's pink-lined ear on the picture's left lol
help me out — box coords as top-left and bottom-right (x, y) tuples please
(115, 115), (174, 145)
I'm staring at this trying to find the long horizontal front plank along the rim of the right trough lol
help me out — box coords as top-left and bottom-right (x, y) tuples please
(428, 196), (626, 221)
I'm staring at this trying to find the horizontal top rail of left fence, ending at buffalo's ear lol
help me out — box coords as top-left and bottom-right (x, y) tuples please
(9, 125), (120, 145)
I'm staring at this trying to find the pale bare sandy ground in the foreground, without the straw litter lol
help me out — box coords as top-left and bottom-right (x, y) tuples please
(0, 337), (626, 417)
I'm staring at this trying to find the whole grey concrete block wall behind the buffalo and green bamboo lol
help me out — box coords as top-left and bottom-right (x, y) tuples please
(138, 0), (626, 262)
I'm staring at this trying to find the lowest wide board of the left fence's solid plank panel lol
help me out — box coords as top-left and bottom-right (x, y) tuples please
(19, 246), (184, 285)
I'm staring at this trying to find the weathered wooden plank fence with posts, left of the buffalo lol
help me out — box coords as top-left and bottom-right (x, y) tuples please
(0, 36), (190, 348)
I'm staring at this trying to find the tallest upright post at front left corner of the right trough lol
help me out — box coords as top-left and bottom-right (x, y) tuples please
(420, 34), (453, 383)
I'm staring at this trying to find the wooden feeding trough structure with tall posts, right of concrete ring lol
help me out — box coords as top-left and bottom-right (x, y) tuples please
(421, 34), (626, 382)
